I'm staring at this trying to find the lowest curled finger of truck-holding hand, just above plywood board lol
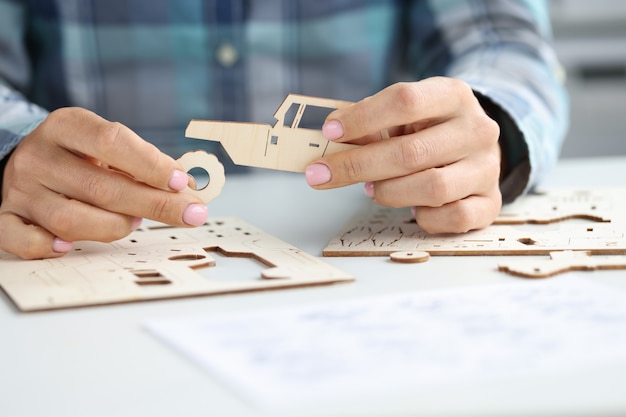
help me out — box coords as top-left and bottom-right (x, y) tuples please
(415, 191), (502, 234)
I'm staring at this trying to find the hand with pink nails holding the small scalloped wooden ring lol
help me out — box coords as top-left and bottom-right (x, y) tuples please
(0, 108), (207, 259)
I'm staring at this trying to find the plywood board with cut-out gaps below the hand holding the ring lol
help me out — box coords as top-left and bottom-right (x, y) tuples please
(0, 218), (354, 311)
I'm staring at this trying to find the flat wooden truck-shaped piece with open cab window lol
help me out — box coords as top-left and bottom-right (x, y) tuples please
(185, 94), (360, 172)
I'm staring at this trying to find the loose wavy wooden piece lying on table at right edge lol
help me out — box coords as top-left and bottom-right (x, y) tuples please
(498, 251), (626, 278)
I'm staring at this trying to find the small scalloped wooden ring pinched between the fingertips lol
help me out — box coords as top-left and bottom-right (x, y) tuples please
(176, 151), (226, 203)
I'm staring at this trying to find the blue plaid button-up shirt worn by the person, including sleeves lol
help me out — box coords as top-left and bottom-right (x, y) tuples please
(0, 0), (567, 200)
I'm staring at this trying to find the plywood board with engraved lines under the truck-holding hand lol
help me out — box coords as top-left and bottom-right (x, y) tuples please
(323, 189), (626, 256)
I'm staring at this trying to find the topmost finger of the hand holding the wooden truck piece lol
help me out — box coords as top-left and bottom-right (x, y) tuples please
(322, 77), (468, 142)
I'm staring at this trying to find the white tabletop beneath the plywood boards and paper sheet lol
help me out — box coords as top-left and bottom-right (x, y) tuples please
(0, 157), (626, 417)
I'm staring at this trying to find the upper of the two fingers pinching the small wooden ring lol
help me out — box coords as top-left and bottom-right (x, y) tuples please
(38, 108), (188, 191)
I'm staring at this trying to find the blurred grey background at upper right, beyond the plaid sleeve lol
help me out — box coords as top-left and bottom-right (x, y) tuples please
(549, 0), (626, 158)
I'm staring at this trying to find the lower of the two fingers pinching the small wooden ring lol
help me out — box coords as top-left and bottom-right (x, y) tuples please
(35, 153), (206, 226)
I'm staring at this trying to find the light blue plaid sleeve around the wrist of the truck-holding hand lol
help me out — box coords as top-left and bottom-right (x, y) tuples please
(422, 0), (569, 202)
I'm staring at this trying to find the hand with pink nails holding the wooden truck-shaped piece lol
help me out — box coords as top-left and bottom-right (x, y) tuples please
(305, 77), (502, 233)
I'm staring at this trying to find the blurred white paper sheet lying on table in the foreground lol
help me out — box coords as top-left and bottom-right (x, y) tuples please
(148, 277), (626, 407)
